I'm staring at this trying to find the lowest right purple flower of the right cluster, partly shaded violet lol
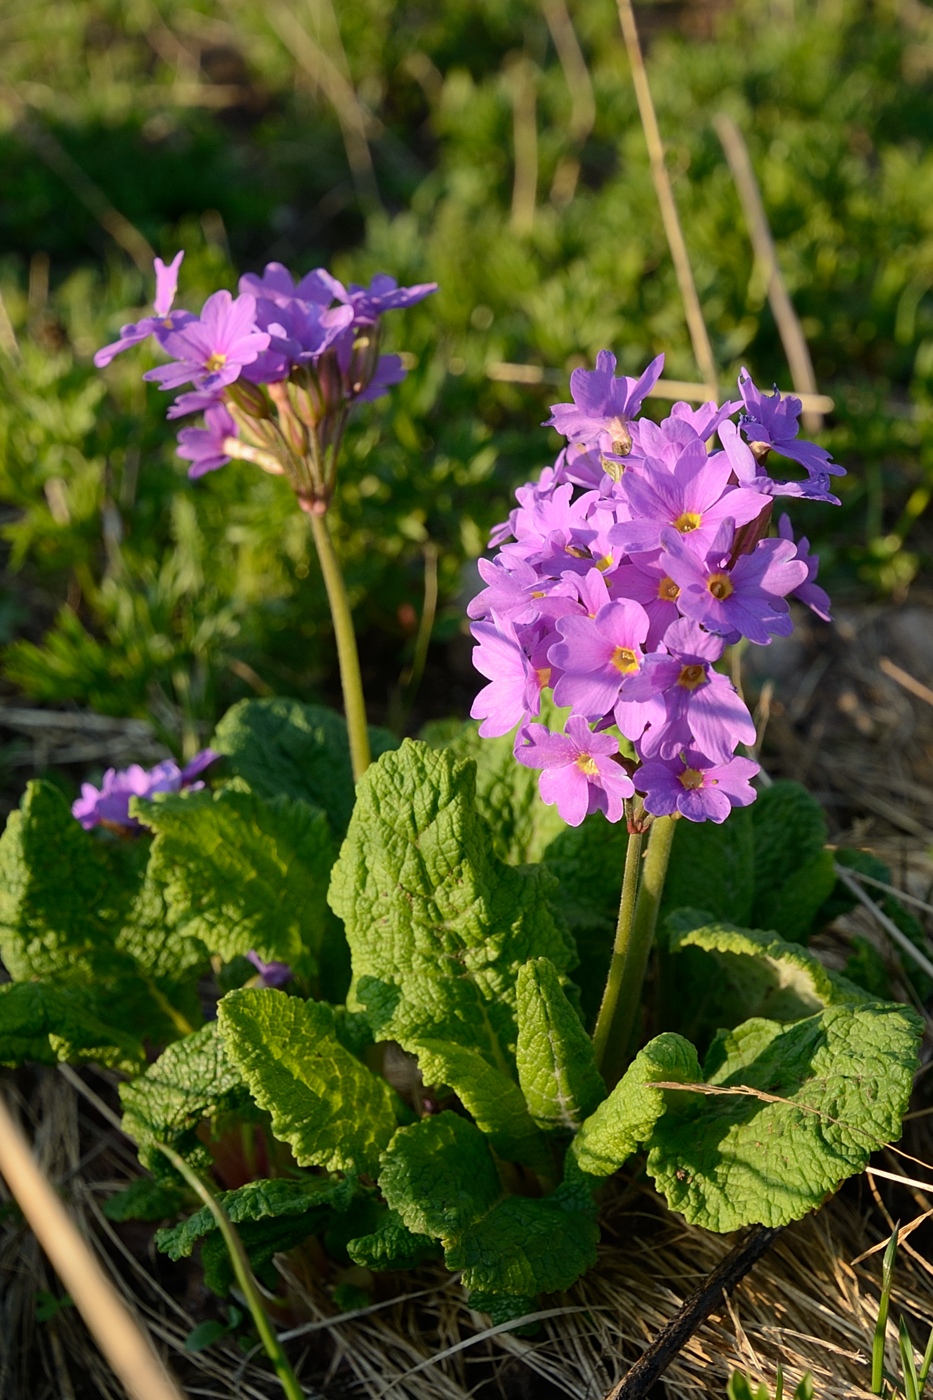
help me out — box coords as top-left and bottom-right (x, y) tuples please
(635, 749), (759, 822)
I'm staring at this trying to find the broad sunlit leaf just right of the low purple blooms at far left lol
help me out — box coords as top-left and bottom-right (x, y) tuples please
(132, 788), (333, 972)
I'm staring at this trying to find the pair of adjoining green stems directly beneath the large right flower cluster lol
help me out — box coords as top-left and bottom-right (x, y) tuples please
(594, 816), (677, 1088)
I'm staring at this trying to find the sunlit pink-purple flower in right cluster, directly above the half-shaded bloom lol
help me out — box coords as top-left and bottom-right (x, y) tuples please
(609, 441), (769, 553)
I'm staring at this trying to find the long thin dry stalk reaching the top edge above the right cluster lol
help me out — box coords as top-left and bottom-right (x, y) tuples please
(616, 0), (719, 399)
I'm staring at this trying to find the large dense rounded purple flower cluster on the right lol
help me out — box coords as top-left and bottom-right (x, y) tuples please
(467, 350), (842, 826)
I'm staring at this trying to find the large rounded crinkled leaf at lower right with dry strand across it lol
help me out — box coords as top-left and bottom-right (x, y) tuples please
(647, 1002), (920, 1231)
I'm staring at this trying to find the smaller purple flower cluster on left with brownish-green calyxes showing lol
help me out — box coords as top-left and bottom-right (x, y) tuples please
(100, 253), (437, 511)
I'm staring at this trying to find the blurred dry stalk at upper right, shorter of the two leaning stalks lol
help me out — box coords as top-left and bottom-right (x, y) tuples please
(713, 112), (822, 433)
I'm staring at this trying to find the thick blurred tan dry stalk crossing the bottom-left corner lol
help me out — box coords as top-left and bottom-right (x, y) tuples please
(0, 1098), (182, 1400)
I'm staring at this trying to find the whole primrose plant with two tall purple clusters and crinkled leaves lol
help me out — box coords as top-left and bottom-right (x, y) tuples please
(0, 259), (929, 1338)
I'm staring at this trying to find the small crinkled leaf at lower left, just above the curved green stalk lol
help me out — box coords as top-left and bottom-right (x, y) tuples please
(119, 1021), (251, 1179)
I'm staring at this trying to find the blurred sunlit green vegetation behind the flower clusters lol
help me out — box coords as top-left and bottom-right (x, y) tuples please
(0, 0), (933, 767)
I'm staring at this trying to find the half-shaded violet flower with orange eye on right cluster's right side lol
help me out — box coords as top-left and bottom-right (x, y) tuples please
(661, 521), (807, 647)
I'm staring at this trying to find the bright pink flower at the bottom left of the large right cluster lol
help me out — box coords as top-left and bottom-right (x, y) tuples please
(516, 714), (635, 826)
